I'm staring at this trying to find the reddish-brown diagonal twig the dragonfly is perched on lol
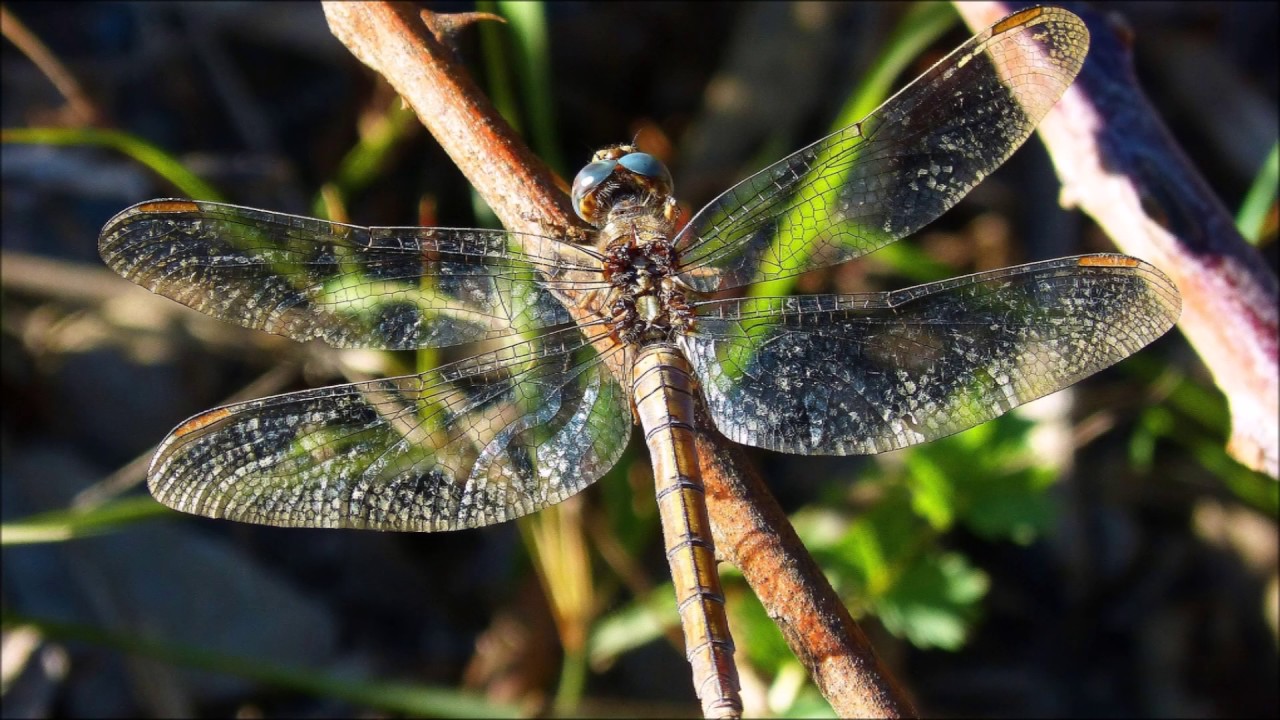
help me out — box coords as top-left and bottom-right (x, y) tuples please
(325, 3), (914, 717)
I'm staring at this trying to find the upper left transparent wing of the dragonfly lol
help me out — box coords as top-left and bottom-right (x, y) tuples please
(99, 200), (603, 350)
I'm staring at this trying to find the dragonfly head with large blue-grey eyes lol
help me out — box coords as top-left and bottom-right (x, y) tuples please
(572, 145), (676, 227)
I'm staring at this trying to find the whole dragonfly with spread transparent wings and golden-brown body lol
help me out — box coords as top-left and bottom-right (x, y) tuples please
(100, 8), (1180, 717)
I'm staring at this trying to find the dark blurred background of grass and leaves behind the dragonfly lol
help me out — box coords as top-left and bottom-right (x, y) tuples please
(0, 3), (1280, 717)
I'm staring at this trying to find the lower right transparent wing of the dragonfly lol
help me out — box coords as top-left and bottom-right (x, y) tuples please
(681, 255), (1181, 455)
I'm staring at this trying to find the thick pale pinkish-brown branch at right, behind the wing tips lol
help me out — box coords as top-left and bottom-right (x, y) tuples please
(956, 3), (1280, 478)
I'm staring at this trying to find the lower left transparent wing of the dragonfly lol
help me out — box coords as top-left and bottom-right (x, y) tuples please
(148, 322), (631, 530)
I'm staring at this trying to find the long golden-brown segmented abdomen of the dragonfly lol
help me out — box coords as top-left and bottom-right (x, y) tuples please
(631, 343), (742, 717)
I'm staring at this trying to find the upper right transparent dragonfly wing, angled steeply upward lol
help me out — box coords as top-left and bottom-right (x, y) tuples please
(678, 8), (1088, 292)
